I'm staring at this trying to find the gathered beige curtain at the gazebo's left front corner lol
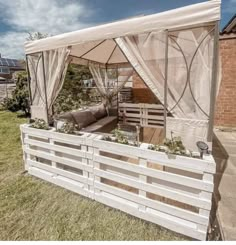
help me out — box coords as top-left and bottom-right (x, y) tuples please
(28, 47), (70, 121)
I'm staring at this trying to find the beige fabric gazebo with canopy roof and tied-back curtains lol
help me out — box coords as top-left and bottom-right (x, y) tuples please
(25, 0), (221, 148)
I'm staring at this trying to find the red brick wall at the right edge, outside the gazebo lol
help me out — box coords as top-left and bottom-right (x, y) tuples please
(215, 36), (236, 127)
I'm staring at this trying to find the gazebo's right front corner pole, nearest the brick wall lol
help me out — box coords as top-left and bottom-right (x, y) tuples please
(207, 21), (219, 142)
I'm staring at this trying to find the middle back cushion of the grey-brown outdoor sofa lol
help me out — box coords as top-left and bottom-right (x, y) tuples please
(71, 110), (97, 128)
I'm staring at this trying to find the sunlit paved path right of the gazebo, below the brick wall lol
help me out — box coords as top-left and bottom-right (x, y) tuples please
(213, 131), (236, 241)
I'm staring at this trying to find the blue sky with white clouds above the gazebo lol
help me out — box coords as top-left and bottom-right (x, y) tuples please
(0, 0), (236, 58)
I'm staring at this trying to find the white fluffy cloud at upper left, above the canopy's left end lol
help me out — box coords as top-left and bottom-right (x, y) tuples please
(0, 0), (92, 57)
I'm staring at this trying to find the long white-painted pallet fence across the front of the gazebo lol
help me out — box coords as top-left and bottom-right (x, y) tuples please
(21, 125), (216, 240)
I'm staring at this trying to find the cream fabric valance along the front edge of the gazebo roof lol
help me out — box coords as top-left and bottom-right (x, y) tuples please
(25, 0), (221, 56)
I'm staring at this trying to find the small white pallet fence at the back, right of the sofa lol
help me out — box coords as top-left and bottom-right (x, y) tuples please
(119, 103), (164, 128)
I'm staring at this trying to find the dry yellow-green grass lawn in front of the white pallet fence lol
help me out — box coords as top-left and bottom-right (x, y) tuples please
(0, 111), (186, 240)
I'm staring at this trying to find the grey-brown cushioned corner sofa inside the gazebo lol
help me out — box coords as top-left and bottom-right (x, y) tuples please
(57, 104), (118, 133)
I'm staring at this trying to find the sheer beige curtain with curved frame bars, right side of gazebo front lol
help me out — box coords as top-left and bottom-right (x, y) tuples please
(116, 26), (214, 120)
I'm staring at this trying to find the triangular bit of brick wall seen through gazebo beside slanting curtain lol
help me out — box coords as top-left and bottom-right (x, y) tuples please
(133, 72), (159, 104)
